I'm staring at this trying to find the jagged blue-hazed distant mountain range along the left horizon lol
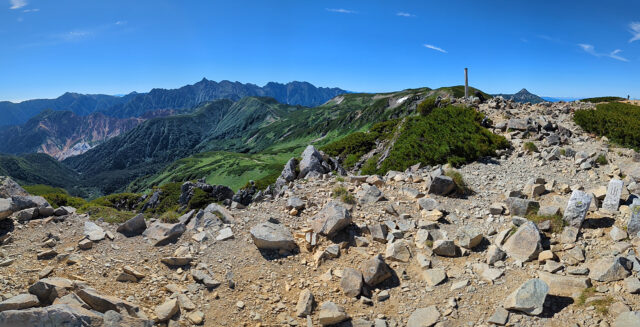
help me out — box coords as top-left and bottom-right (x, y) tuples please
(0, 79), (347, 126)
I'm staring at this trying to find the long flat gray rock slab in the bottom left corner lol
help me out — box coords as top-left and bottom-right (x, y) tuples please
(0, 304), (103, 327)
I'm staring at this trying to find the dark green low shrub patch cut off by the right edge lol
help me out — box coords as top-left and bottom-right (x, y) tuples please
(573, 102), (640, 150)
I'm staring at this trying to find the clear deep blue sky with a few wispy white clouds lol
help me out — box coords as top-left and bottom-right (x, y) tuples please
(0, 0), (640, 100)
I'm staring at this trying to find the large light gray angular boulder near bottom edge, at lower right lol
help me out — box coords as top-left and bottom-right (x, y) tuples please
(504, 279), (549, 316)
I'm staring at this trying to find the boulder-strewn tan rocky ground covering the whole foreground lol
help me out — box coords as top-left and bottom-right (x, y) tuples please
(0, 98), (640, 327)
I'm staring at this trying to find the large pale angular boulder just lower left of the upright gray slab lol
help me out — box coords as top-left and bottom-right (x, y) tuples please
(502, 221), (542, 262)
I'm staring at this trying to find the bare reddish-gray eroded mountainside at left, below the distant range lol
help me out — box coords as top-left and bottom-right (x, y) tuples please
(0, 110), (143, 160)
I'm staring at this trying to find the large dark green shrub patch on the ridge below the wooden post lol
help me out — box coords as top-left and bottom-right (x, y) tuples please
(322, 104), (509, 174)
